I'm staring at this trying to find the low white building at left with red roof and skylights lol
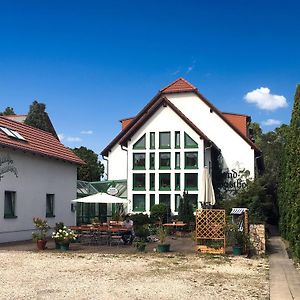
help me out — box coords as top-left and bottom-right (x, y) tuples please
(0, 117), (84, 243)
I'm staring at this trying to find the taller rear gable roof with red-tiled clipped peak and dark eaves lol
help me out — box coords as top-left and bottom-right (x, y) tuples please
(101, 78), (261, 156)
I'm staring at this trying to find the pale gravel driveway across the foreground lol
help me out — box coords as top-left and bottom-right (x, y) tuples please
(0, 249), (269, 300)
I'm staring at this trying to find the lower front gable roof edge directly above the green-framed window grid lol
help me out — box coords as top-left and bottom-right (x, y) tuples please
(119, 97), (211, 145)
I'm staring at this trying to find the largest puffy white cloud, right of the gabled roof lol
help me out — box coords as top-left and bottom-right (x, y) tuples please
(244, 87), (288, 110)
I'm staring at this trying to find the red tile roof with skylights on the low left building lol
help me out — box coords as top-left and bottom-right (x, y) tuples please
(0, 117), (85, 164)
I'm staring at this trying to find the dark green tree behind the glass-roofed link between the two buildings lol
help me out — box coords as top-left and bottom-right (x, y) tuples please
(71, 146), (104, 181)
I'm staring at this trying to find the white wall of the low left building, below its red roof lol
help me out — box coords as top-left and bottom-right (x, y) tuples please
(0, 148), (77, 243)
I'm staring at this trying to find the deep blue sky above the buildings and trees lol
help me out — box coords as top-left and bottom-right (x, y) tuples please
(0, 0), (300, 153)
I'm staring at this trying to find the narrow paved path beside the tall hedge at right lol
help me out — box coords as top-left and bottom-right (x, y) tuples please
(269, 235), (300, 300)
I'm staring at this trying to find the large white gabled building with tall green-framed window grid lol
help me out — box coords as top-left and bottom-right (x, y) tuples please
(101, 78), (261, 214)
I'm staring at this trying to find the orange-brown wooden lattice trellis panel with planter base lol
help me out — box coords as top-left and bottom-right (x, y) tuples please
(196, 209), (226, 254)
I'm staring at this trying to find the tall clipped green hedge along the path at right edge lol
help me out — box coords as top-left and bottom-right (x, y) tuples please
(279, 85), (300, 258)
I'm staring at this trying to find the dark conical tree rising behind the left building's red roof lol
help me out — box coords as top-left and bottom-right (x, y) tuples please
(24, 101), (57, 137)
